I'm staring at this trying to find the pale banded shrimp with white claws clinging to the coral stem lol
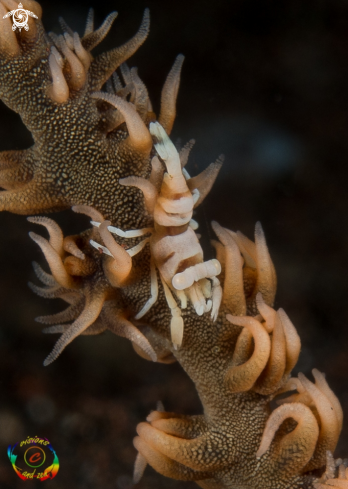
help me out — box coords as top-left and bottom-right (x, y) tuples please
(91, 120), (222, 348)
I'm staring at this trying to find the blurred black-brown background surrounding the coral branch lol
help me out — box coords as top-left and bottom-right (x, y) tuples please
(0, 0), (348, 489)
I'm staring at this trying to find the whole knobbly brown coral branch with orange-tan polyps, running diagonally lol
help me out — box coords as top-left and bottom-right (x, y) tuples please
(0, 0), (347, 489)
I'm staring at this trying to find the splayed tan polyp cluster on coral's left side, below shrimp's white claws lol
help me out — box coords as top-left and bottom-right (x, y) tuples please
(29, 206), (156, 365)
